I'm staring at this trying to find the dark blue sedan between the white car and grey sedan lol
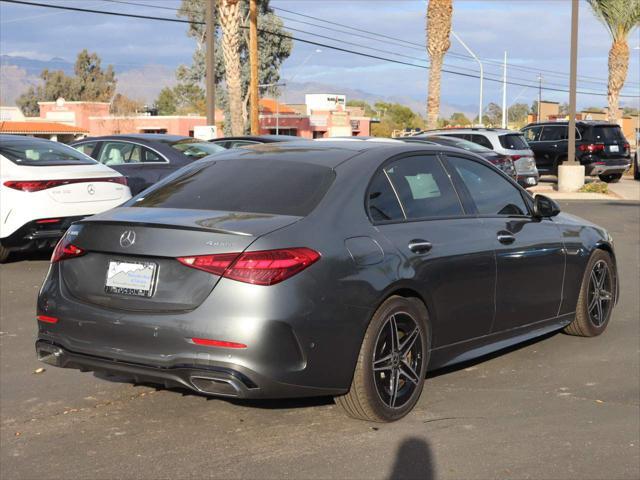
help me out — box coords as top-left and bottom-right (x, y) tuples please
(71, 133), (224, 195)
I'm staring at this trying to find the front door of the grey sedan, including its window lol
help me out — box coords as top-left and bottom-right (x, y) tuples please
(447, 154), (565, 332)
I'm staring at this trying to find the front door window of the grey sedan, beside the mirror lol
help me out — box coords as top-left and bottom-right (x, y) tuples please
(448, 156), (529, 215)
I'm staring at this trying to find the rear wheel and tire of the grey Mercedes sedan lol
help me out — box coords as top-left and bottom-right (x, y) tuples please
(335, 296), (431, 422)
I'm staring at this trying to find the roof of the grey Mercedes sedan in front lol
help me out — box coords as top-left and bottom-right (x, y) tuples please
(206, 140), (460, 168)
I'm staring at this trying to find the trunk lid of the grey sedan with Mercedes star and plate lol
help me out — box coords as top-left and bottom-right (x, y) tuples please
(60, 207), (300, 313)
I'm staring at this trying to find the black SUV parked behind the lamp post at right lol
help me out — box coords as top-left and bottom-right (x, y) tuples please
(522, 121), (631, 183)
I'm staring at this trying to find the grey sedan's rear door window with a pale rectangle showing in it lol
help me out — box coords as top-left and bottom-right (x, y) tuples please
(384, 155), (464, 220)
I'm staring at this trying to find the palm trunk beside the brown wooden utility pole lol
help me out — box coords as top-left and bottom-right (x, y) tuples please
(218, 0), (244, 135)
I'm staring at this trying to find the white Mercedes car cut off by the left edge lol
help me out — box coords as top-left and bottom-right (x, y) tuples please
(0, 135), (131, 263)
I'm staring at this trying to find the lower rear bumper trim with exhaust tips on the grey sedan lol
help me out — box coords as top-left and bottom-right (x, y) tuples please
(36, 339), (346, 399)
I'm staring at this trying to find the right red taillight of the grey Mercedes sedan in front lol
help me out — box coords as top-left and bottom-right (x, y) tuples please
(178, 248), (320, 285)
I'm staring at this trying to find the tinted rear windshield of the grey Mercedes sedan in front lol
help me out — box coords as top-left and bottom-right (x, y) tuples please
(133, 159), (335, 216)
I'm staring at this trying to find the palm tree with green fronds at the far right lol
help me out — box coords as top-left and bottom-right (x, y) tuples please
(588, 0), (640, 122)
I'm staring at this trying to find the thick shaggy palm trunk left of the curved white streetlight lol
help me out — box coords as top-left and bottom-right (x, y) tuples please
(427, 0), (453, 128)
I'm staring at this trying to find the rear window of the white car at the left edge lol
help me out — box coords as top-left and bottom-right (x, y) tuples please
(0, 138), (96, 166)
